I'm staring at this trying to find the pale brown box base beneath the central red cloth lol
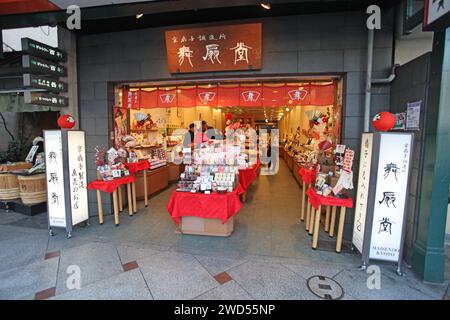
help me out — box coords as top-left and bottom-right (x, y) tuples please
(180, 216), (235, 237)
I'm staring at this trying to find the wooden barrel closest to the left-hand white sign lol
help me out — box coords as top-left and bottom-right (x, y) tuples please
(18, 173), (47, 204)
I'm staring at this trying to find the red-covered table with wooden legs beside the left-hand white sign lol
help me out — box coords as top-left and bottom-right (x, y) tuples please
(87, 175), (136, 226)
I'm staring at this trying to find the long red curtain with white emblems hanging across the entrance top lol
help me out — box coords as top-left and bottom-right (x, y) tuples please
(122, 82), (335, 110)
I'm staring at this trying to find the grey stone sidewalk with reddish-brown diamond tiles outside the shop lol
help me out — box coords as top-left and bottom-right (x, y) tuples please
(0, 213), (448, 300)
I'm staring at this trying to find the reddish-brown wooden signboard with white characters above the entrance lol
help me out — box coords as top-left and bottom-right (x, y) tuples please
(166, 23), (262, 73)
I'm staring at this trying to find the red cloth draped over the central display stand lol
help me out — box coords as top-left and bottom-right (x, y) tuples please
(166, 190), (242, 224)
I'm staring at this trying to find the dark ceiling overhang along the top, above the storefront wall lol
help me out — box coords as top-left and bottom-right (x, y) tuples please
(0, 0), (400, 34)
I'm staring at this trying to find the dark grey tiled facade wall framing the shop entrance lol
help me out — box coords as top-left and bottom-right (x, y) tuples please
(78, 10), (394, 239)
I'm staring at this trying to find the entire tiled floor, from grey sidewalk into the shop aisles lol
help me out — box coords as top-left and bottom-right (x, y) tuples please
(0, 162), (448, 300)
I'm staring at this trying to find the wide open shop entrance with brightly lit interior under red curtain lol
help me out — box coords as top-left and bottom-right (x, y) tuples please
(111, 76), (342, 256)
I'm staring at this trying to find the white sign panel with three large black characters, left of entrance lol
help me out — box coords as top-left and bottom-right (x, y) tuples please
(44, 131), (66, 228)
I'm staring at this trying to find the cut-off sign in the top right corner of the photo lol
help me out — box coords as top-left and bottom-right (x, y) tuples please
(423, 0), (450, 31)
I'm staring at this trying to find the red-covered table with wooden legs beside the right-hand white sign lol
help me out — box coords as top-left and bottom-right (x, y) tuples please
(306, 188), (353, 252)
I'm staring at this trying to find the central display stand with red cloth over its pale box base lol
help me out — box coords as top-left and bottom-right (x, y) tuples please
(166, 188), (242, 236)
